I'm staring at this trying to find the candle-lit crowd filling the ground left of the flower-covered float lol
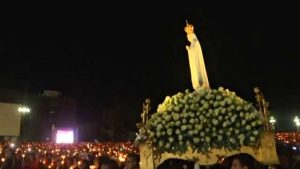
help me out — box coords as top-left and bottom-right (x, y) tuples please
(0, 142), (139, 169)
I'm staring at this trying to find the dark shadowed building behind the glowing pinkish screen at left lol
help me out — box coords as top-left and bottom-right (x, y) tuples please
(0, 89), (77, 141)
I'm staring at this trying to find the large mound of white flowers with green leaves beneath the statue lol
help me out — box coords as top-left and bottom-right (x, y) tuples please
(137, 87), (263, 153)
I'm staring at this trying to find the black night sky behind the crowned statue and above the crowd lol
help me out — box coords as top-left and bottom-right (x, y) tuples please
(0, 4), (300, 135)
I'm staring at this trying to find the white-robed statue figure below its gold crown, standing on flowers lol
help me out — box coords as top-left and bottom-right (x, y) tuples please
(186, 33), (209, 90)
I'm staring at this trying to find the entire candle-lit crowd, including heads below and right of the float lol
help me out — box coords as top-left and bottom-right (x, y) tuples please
(0, 139), (300, 169)
